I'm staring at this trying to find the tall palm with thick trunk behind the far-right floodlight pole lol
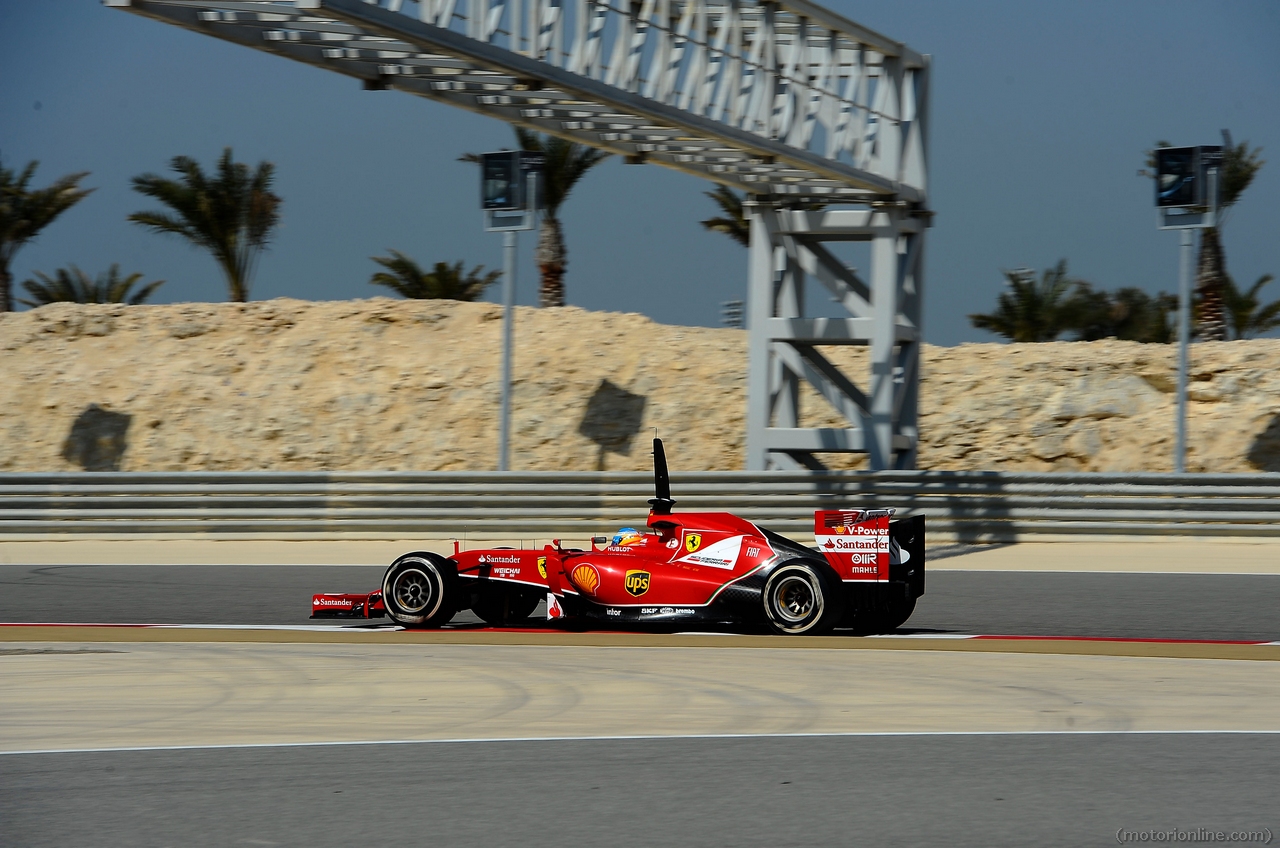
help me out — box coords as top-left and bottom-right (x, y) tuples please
(1147, 129), (1266, 342)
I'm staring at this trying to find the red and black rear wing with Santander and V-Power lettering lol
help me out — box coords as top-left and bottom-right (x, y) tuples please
(813, 510), (924, 597)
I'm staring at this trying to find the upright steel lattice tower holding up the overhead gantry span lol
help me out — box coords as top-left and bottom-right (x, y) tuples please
(746, 202), (927, 471)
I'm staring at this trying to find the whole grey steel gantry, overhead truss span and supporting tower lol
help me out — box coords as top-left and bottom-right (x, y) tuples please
(106, 0), (929, 469)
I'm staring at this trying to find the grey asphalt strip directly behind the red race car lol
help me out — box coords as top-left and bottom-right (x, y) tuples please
(0, 565), (1280, 640)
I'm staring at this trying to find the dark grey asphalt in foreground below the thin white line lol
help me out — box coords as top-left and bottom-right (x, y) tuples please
(0, 734), (1280, 848)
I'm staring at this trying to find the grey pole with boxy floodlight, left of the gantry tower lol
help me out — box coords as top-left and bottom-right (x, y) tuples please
(480, 150), (545, 471)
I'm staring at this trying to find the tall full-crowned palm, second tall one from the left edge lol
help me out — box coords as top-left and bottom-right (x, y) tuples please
(129, 147), (280, 304)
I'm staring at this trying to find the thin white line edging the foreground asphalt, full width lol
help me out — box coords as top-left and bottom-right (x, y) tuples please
(0, 730), (1280, 757)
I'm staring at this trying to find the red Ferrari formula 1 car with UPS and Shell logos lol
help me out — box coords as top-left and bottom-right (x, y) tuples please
(311, 439), (924, 635)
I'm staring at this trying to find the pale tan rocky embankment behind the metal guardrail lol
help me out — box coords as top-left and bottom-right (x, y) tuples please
(0, 298), (1280, 471)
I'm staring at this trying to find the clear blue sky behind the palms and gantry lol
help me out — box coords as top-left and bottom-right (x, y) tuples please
(0, 0), (1280, 345)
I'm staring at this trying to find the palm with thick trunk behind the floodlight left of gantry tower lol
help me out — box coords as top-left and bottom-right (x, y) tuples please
(461, 127), (609, 306)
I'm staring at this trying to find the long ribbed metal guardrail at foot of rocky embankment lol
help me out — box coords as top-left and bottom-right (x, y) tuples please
(0, 471), (1280, 542)
